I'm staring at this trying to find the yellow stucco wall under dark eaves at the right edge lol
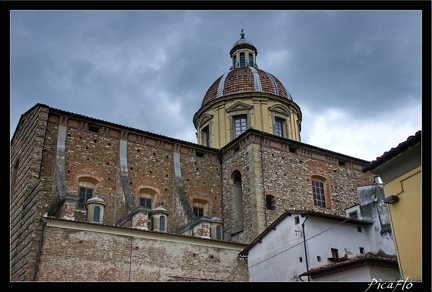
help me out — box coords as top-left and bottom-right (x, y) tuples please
(384, 166), (422, 281)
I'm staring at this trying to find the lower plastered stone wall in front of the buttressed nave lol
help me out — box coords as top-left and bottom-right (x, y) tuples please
(37, 219), (249, 282)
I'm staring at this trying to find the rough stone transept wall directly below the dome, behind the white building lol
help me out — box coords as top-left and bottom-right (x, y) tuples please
(219, 135), (374, 243)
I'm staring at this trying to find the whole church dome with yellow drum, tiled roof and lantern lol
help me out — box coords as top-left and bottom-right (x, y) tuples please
(193, 29), (302, 149)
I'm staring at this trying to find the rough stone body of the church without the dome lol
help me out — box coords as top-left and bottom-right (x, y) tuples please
(11, 104), (374, 281)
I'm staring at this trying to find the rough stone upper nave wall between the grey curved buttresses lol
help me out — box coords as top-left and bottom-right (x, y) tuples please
(48, 113), (222, 232)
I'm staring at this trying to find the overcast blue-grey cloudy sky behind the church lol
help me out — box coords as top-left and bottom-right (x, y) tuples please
(10, 10), (422, 161)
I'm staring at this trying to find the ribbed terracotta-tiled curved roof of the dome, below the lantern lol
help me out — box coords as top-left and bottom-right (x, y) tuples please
(202, 67), (292, 106)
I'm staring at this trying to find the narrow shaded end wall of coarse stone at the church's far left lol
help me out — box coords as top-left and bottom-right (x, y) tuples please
(10, 108), (53, 281)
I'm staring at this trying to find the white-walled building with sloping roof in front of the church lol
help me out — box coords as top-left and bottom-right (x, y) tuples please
(240, 210), (400, 282)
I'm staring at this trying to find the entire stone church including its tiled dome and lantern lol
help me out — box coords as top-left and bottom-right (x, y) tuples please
(10, 32), (375, 282)
